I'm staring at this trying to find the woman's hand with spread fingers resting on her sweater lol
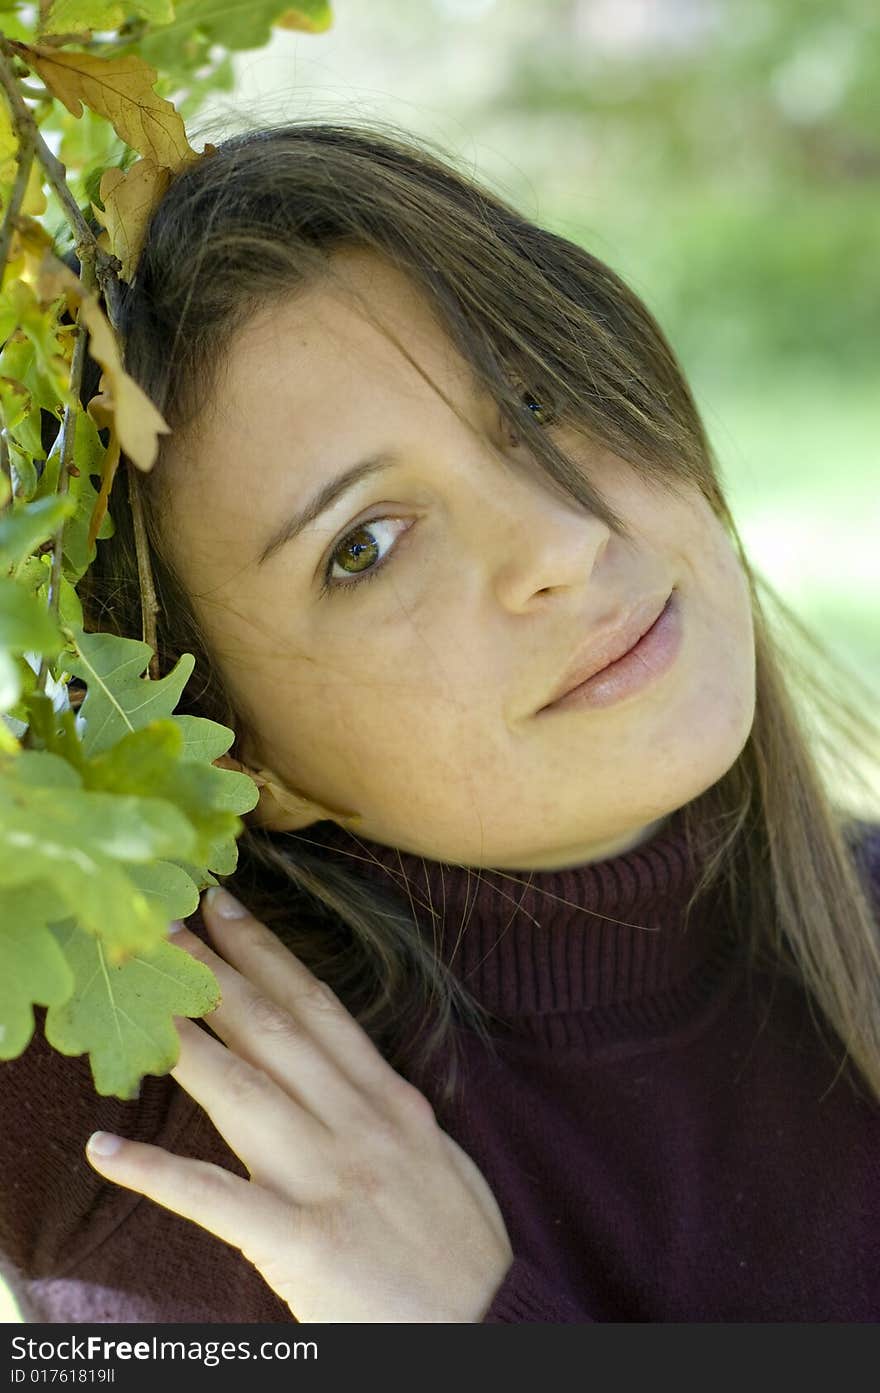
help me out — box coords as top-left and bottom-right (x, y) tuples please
(86, 896), (512, 1323)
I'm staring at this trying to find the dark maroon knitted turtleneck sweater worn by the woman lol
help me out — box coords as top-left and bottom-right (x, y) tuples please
(0, 814), (880, 1323)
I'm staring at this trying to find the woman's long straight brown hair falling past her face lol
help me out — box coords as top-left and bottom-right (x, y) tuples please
(73, 124), (880, 1100)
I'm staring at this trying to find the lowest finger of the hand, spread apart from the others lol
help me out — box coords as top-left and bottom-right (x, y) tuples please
(85, 1133), (298, 1262)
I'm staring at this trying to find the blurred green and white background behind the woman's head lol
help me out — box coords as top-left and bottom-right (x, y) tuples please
(0, 0), (880, 1319)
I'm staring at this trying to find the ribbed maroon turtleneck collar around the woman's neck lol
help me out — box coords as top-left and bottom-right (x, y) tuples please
(301, 809), (731, 1042)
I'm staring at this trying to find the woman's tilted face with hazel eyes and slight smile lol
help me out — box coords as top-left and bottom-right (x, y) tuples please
(164, 251), (755, 869)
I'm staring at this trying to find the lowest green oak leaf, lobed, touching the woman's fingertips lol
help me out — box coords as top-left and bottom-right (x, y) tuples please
(46, 925), (220, 1099)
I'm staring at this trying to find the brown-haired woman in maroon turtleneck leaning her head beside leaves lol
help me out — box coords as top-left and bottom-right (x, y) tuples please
(0, 117), (880, 1322)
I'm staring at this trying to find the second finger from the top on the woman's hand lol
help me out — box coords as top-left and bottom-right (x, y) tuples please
(174, 929), (363, 1130)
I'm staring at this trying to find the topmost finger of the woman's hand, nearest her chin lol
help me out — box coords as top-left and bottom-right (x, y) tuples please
(202, 892), (409, 1103)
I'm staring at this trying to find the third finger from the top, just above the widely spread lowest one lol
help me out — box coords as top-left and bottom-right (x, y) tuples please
(171, 1017), (331, 1202)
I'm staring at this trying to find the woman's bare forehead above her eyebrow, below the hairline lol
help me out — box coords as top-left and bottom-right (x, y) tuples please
(166, 249), (485, 571)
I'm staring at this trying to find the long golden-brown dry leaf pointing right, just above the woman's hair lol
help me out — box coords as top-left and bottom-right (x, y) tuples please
(10, 43), (198, 170)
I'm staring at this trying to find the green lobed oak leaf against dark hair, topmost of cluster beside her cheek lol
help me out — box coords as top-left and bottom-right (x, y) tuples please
(64, 630), (195, 755)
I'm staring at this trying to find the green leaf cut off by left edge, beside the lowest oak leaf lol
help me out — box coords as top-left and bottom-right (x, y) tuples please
(0, 885), (74, 1059)
